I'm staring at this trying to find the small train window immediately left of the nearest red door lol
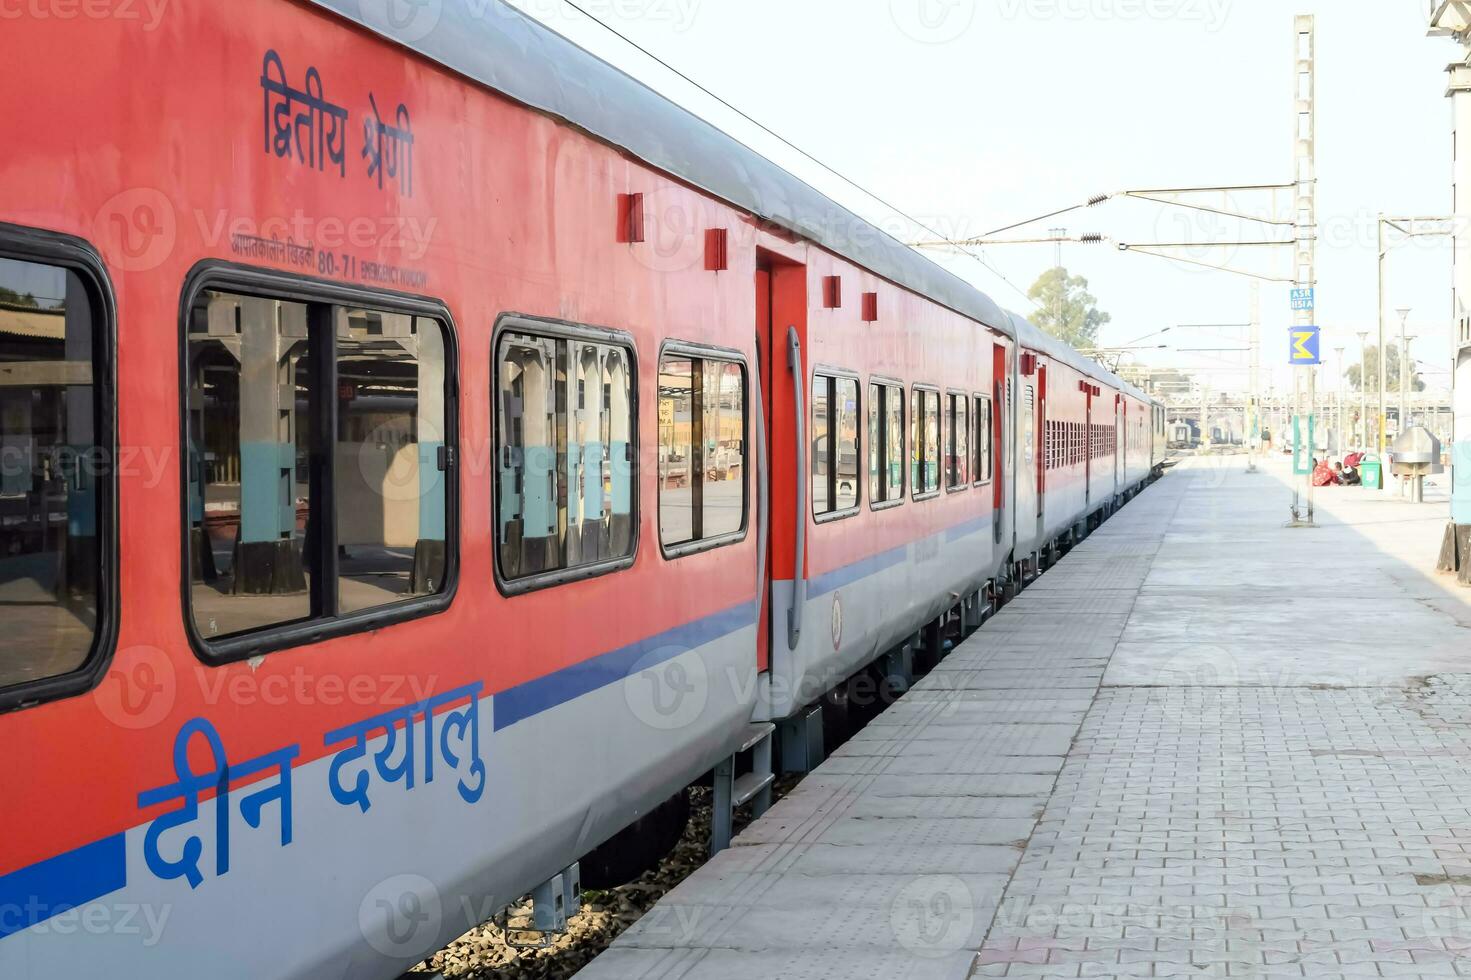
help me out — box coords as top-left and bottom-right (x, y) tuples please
(659, 350), (746, 556)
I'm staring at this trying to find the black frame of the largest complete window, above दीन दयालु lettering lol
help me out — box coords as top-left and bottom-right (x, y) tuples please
(177, 259), (462, 667)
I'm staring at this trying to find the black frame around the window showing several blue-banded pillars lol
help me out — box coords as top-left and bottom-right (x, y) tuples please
(487, 313), (643, 588)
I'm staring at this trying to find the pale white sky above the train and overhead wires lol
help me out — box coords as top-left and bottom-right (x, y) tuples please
(512, 0), (1458, 390)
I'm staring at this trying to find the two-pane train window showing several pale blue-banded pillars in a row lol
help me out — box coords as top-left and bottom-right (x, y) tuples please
(491, 316), (638, 579)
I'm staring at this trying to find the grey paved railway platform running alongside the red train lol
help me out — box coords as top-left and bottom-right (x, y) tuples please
(578, 456), (1471, 980)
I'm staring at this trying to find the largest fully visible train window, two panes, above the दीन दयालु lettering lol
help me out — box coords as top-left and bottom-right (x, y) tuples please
(182, 266), (456, 662)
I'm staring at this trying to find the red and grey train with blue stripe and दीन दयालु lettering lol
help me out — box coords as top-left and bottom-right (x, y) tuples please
(0, 0), (1155, 979)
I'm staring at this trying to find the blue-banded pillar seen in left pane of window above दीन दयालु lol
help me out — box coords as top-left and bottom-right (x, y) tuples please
(220, 296), (306, 596)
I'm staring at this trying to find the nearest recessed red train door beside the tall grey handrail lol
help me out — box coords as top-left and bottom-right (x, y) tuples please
(755, 252), (809, 672)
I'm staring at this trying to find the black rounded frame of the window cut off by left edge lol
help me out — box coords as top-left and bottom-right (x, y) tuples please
(0, 222), (121, 714)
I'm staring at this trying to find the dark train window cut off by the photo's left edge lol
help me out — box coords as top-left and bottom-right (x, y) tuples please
(0, 225), (116, 709)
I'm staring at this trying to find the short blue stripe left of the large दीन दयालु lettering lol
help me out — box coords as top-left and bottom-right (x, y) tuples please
(0, 834), (128, 939)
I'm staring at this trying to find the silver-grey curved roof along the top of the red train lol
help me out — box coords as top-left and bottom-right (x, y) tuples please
(312, 0), (1143, 397)
